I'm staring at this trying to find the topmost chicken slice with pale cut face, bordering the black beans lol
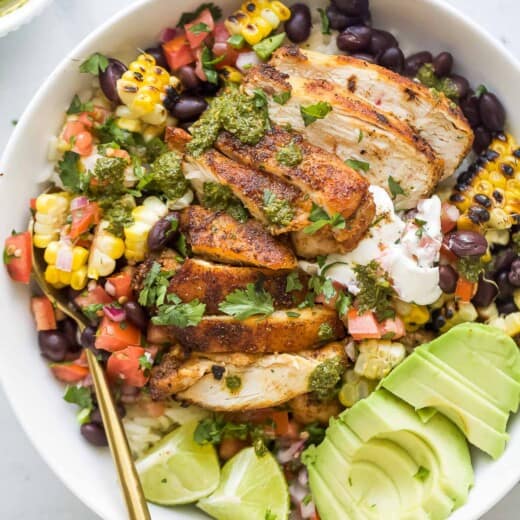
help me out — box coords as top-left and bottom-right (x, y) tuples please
(270, 46), (473, 178)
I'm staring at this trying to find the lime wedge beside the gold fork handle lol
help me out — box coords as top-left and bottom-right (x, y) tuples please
(136, 421), (220, 506)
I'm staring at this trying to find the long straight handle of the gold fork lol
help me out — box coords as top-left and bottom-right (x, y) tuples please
(85, 349), (151, 520)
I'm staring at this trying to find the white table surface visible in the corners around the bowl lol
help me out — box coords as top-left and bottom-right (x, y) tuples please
(0, 0), (520, 520)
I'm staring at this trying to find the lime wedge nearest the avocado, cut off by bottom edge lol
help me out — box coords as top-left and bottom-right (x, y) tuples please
(197, 448), (289, 520)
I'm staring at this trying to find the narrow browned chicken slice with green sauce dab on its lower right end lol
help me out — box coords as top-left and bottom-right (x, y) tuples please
(166, 128), (312, 235)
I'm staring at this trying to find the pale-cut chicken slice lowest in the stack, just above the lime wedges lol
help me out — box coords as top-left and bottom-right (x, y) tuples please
(150, 343), (347, 412)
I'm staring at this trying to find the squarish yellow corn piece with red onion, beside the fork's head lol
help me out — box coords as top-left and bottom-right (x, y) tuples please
(43, 240), (88, 291)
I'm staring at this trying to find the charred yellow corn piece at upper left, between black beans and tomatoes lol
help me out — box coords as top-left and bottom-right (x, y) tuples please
(116, 54), (170, 126)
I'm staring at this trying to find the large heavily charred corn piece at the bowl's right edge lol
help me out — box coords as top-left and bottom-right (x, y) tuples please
(450, 134), (520, 230)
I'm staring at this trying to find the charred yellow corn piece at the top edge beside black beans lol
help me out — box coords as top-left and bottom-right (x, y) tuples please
(225, 0), (291, 45)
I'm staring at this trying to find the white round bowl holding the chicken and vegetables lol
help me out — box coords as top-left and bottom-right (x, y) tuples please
(0, 0), (520, 520)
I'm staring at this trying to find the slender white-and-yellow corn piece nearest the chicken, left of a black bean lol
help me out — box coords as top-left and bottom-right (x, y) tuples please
(124, 197), (168, 262)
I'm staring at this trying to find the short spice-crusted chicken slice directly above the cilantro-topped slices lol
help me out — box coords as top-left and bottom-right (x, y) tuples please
(180, 206), (296, 270)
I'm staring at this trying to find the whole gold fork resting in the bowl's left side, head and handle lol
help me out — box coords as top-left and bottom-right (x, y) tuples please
(29, 220), (151, 520)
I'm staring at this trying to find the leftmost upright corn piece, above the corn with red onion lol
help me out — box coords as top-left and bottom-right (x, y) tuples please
(33, 191), (70, 248)
